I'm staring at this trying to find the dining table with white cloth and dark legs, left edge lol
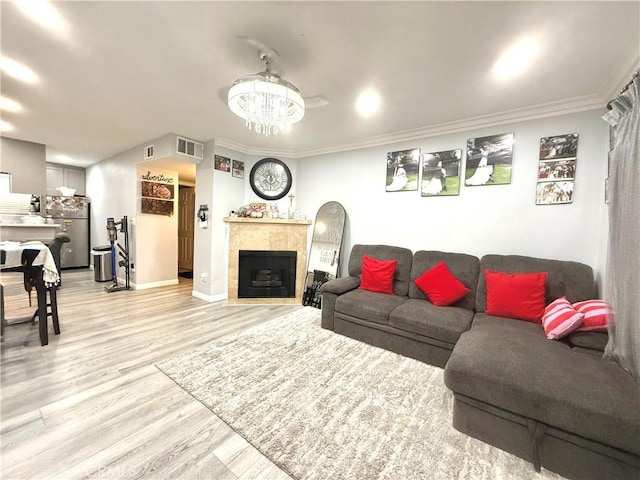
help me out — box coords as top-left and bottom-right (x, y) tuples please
(0, 241), (60, 346)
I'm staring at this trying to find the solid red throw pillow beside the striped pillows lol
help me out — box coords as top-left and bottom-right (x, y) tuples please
(484, 270), (547, 323)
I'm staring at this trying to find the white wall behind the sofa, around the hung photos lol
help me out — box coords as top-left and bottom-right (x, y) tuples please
(295, 110), (608, 284)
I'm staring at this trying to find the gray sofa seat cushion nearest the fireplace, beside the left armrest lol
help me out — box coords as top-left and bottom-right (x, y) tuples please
(336, 289), (407, 325)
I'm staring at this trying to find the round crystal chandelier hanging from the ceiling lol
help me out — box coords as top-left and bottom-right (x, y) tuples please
(227, 52), (304, 137)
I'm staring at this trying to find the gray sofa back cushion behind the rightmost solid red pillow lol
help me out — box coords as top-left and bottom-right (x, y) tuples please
(476, 255), (596, 312)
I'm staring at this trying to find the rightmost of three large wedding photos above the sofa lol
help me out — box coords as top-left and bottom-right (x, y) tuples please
(464, 133), (514, 186)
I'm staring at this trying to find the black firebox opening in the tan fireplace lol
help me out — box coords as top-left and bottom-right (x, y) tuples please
(238, 250), (298, 298)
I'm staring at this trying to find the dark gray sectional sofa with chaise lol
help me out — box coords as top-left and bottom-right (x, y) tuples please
(322, 245), (640, 479)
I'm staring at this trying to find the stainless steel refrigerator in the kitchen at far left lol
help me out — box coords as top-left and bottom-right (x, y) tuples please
(45, 195), (90, 268)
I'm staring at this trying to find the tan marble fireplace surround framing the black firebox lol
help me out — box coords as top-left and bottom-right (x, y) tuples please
(224, 217), (311, 305)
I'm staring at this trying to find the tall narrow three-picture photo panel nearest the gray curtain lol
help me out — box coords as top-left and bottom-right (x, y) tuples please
(536, 133), (578, 205)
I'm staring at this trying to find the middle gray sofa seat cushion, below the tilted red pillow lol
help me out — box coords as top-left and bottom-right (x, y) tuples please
(389, 299), (473, 344)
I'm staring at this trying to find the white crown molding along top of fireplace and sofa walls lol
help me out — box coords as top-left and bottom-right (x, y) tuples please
(215, 94), (607, 159)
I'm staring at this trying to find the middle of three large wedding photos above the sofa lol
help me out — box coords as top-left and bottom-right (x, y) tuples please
(420, 149), (462, 197)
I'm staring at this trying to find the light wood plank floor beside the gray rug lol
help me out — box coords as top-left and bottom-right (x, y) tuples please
(1, 270), (302, 480)
